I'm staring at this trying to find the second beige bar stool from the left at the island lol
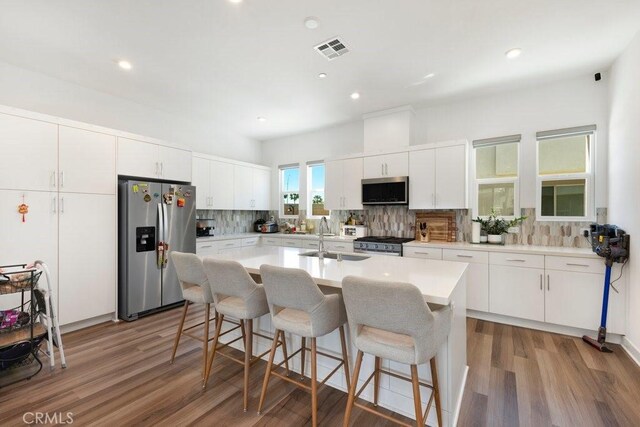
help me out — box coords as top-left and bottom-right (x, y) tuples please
(202, 258), (284, 412)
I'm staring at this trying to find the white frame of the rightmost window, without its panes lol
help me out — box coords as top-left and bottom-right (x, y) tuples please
(535, 126), (596, 222)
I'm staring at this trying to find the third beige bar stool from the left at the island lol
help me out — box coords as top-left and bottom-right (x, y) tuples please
(258, 265), (350, 426)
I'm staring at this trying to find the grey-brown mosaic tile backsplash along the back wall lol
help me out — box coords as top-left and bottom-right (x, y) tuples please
(269, 206), (607, 248)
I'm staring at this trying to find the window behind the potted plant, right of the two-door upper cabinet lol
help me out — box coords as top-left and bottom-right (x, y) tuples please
(473, 135), (520, 217)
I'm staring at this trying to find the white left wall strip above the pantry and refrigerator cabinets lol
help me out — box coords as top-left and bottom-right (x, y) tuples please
(0, 62), (262, 163)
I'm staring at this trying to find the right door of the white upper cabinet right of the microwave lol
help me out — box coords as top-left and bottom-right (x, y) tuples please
(436, 145), (467, 209)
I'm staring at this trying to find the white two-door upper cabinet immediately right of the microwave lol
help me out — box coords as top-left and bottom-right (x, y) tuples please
(409, 144), (467, 209)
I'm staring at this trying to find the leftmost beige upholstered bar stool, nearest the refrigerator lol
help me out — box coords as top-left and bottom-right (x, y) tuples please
(170, 251), (215, 378)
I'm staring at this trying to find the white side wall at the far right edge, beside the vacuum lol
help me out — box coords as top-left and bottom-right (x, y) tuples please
(609, 33), (640, 351)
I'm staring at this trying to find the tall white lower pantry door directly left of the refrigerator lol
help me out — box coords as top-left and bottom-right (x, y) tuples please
(58, 193), (116, 325)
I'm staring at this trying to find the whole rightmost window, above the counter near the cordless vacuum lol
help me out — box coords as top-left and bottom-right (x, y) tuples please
(536, 125), (596, 221)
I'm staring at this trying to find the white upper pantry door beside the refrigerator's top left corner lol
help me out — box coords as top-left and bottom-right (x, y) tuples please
(58, 126), (116, 194)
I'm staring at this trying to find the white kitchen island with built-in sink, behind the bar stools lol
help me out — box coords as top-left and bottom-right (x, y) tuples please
(206, 246), (468, 425)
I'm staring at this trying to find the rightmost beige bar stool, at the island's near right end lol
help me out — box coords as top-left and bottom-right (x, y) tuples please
(342, 276), (452, 427)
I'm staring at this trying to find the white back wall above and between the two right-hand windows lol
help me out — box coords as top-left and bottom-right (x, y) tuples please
(415, 74), (608, 208)
